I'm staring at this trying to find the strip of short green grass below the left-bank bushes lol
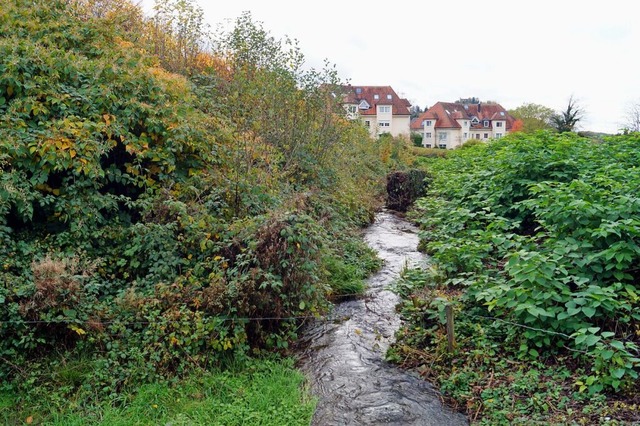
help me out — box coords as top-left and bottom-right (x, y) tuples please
(0, 359), (315, 426)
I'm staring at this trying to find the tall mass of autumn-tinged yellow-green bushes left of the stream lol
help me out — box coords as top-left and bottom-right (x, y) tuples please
(0, 0), (411, 416)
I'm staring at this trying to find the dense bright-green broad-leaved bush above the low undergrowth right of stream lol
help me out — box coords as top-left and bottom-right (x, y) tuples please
(392, 132), (640, 400)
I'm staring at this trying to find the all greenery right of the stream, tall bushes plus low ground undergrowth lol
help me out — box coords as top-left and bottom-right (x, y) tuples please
(389, 132), (640, 424)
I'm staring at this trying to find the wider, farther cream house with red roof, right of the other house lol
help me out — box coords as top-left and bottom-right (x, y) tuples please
(411, 101), (515, 149)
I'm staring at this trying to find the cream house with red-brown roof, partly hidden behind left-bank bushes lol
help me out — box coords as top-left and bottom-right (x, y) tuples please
(341, 85), (411, 137)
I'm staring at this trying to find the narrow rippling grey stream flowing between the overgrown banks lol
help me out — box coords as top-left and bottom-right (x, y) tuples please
(299, 211), (468, 426)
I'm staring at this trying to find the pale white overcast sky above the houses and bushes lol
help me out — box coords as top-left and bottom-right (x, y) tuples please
(143, 0), (640, 133)
